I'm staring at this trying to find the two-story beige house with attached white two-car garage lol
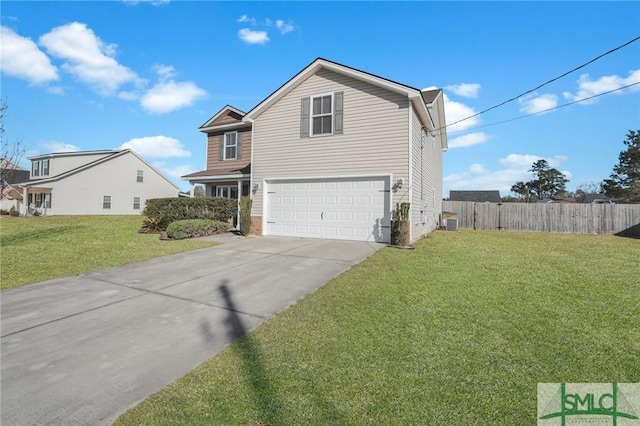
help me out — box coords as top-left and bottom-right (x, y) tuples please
(183, 58), (447, 242)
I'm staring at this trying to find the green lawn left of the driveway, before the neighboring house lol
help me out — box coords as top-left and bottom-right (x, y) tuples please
(0, 216), (215, 289)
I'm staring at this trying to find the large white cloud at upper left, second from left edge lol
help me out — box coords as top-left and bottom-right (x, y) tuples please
(40, 22), (139, 95)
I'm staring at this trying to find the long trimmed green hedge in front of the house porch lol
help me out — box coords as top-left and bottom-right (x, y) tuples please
(142, 197), (238, 229)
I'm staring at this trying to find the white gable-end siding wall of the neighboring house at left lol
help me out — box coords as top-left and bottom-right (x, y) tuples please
(43, 153), (178, 215)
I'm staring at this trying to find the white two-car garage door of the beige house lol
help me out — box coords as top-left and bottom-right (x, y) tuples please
(266, 177), (391, 242)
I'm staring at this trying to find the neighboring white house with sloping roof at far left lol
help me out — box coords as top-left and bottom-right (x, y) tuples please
(19, 149), (180, 215)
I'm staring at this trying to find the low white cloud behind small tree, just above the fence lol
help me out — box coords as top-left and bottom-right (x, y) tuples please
(443, 154), (571, 196)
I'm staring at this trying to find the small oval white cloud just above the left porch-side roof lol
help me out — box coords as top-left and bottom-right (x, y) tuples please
(140, 81), (207, 114)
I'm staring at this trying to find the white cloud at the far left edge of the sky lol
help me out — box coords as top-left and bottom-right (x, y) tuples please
(0, 26), (59, 84)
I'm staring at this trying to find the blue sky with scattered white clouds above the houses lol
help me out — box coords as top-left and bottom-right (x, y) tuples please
(0, 0), (640, 196)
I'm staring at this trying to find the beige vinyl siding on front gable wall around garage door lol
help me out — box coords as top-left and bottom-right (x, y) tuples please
(252, 70), (409, 215)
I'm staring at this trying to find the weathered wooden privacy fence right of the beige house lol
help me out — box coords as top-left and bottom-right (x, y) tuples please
(442, 201), (640, 237)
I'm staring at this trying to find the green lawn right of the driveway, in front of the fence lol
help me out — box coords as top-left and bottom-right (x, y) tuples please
(116, 230), (640, 425)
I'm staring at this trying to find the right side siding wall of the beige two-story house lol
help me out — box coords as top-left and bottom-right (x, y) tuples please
(411, 107), (442, 241)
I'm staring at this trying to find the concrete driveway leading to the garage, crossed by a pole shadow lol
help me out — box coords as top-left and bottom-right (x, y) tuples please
(0, 236), (383, 426)
